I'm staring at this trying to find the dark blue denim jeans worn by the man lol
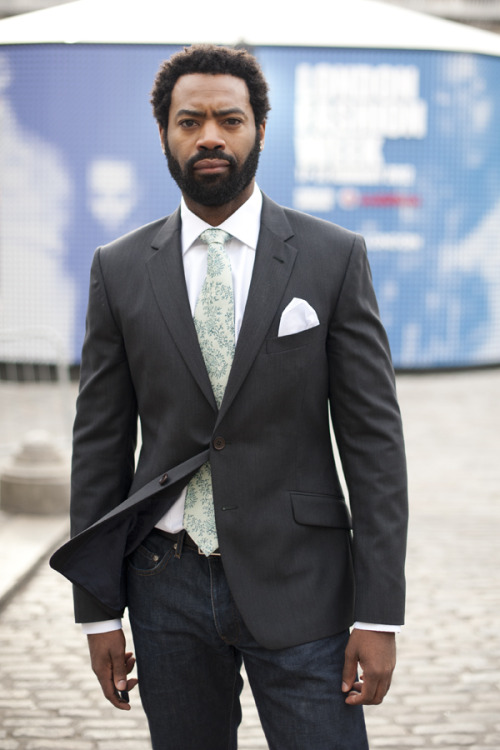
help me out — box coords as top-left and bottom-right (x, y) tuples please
(128, 531), (368, 750)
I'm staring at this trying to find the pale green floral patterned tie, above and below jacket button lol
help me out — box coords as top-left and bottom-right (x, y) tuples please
(184, 229), (235, 555)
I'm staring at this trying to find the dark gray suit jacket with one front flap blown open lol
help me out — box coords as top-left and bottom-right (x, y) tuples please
(51, 196), (407, 648)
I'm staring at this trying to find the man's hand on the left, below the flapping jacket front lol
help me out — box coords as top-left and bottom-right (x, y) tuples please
(87, 630), (137, 711)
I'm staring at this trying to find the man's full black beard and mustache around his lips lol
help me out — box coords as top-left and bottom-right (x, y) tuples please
(165, 132), (260, 206)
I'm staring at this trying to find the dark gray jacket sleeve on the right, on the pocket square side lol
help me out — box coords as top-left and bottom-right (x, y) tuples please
(328, 235), (408, 625)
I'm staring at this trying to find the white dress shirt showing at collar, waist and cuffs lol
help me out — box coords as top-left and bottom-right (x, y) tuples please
(82, 185), (400, 635)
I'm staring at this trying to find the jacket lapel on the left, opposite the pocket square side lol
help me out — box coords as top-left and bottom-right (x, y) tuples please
(147, 209), (217, 410)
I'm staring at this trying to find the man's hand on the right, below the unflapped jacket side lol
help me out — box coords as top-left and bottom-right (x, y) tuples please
(342, 629), (396, 706)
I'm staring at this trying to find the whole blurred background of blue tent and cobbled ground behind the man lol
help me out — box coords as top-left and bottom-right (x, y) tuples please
(0, 0), (500, 750)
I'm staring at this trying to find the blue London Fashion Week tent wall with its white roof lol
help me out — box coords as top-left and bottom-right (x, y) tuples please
(0, 0), (500, 378)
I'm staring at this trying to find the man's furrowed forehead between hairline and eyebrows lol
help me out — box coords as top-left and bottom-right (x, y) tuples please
(170, 73), (252, 116)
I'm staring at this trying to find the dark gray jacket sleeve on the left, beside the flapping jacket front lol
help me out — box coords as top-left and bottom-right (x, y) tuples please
(71, 250), (137, 622)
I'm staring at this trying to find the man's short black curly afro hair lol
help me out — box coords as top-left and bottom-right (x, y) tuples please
(151, 44), (271, 131)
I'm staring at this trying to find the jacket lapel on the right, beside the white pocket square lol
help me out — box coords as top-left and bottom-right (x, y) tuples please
(217, 195), (297, 422)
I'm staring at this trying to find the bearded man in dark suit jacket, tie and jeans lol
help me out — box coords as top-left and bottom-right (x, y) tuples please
(52, 45), (407, 750)
